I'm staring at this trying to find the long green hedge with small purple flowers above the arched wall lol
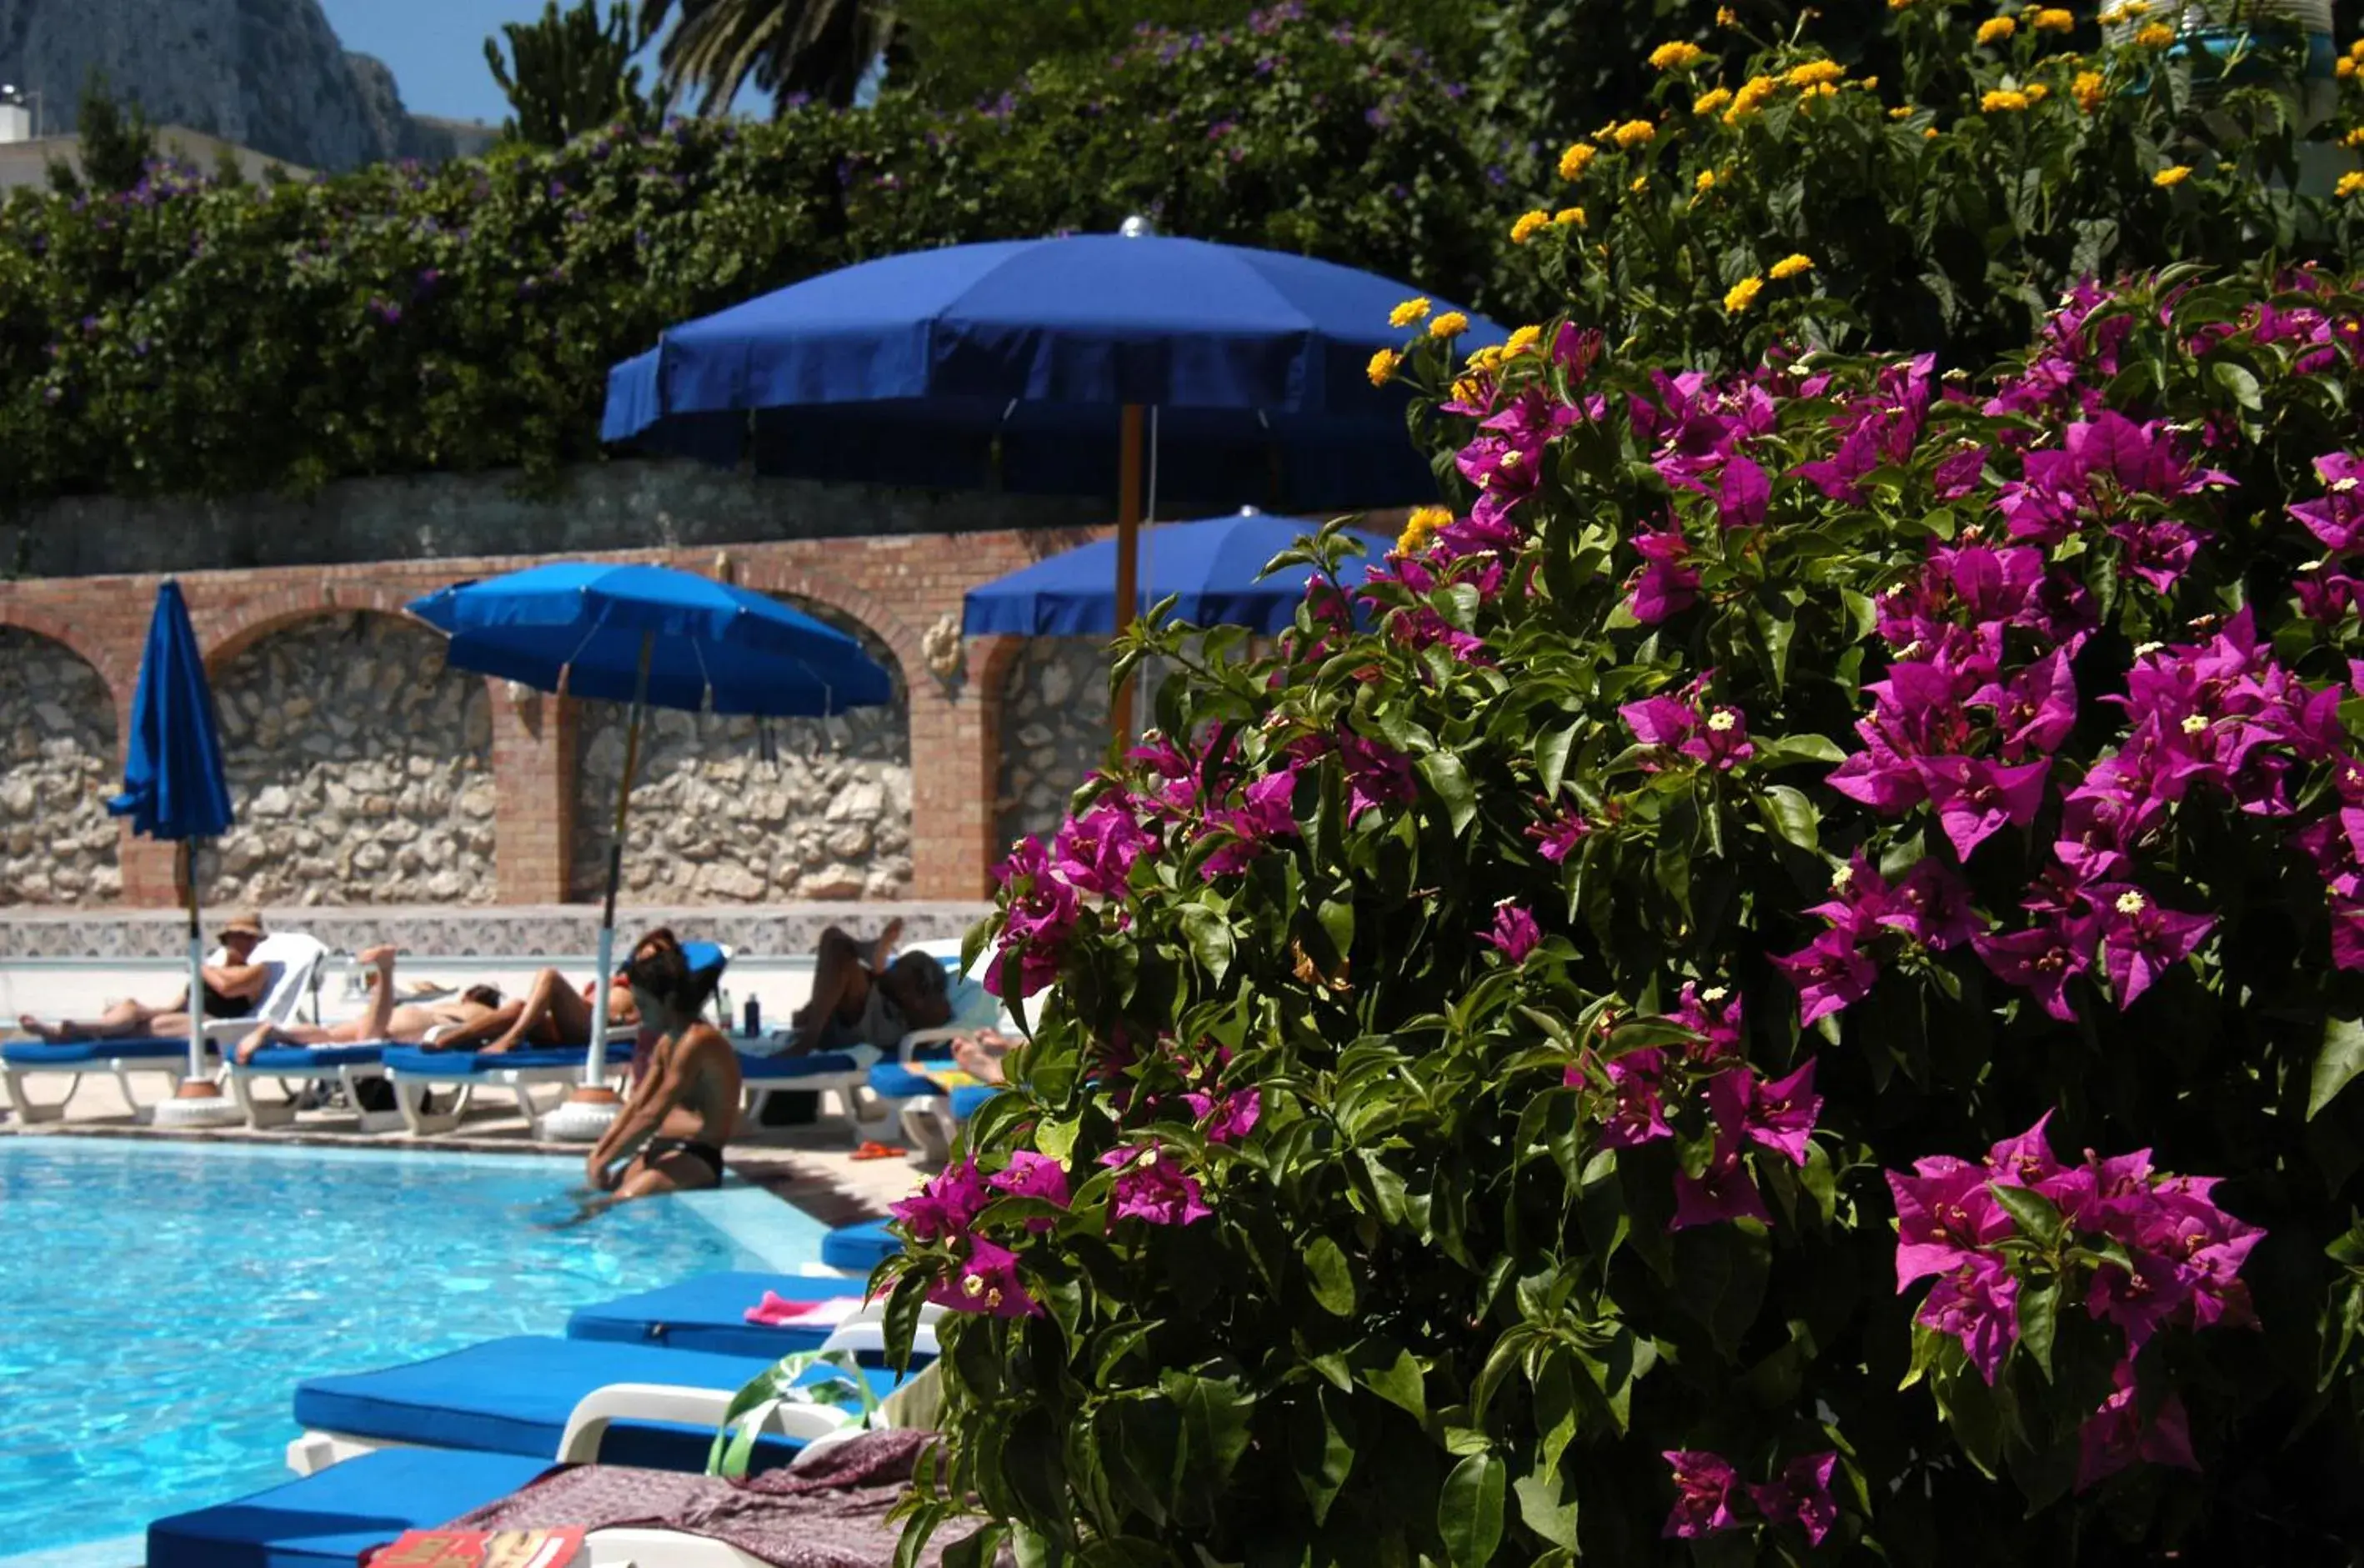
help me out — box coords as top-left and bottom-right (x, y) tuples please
(0, 17), (1508, 506)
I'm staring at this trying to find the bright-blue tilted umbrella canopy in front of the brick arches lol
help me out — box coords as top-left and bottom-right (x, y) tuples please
(409, 563), (894, 717)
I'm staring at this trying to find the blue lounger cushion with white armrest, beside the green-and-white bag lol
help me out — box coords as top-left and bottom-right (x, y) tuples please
(296, 1334), (894, 1469)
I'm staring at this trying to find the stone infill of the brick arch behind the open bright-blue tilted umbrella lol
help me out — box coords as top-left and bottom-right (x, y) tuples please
(572, 594), (913, 904)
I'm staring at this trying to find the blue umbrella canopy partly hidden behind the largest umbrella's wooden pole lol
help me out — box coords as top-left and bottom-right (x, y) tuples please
(959, 511), (1392, 636)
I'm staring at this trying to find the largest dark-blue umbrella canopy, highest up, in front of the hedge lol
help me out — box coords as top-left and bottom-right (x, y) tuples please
(600, 234), (1506, 511)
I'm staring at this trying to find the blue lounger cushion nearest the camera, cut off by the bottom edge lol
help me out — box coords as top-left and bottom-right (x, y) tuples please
(147, 1447), (555, 1568)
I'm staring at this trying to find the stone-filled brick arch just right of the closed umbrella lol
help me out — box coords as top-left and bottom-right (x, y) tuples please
(203, 615), (497, 906)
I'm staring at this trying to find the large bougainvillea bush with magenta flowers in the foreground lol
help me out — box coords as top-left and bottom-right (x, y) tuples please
(889, 272), (2364, 1565)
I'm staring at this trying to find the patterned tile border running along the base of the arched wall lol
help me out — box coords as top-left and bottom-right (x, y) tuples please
(0, 901), (993, 963)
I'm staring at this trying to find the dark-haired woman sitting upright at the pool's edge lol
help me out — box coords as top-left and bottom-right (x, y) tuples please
(579, 936), (740, 1218)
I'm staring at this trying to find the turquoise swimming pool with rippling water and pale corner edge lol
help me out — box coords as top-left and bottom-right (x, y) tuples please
(0, 1138), (823, 1568)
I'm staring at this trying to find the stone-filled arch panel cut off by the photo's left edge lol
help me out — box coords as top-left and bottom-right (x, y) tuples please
(0, 627), (123, 904)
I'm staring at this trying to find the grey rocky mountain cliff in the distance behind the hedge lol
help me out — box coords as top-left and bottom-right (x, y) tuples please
(0, 0), (452, 170)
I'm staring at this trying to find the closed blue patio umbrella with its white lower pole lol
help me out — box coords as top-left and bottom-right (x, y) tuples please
(107, 577), (237, 1097)
